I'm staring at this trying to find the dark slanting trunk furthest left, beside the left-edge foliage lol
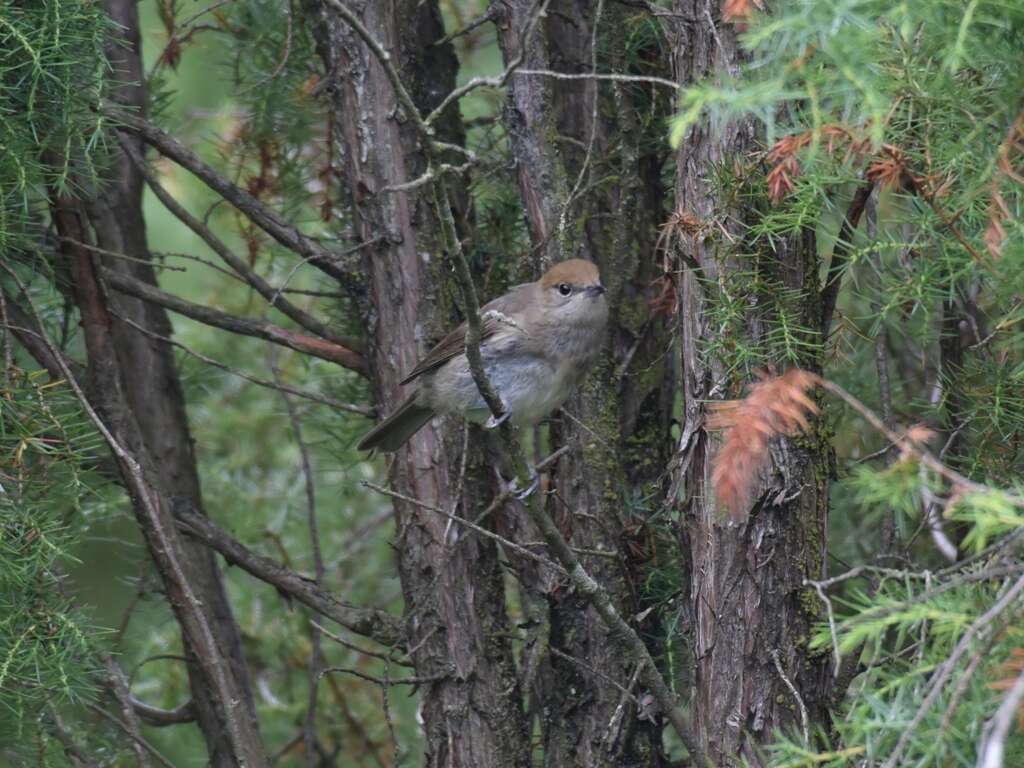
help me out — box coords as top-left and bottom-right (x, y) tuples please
(55, 0), (266, 766)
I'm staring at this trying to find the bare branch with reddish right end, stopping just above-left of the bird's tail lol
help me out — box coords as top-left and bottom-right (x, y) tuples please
(99, 267), (366, 375)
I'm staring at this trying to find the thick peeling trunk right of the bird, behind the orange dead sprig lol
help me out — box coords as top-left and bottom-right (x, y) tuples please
(675, 0), (829, 766)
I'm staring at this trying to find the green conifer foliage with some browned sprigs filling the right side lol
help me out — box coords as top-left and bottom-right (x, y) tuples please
(672, 0), (1024, 768)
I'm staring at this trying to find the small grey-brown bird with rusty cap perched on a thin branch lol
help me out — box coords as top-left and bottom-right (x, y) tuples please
(358, 259), (608, 451)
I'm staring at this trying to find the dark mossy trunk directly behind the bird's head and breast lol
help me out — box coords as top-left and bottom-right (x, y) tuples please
(492, 0), (673, 766)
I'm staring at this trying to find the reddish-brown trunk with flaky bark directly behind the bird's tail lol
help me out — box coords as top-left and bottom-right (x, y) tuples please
(305, 0), (529, 768)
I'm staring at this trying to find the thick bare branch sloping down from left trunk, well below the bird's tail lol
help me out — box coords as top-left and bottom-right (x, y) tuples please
(174, 507), (406, 647)
